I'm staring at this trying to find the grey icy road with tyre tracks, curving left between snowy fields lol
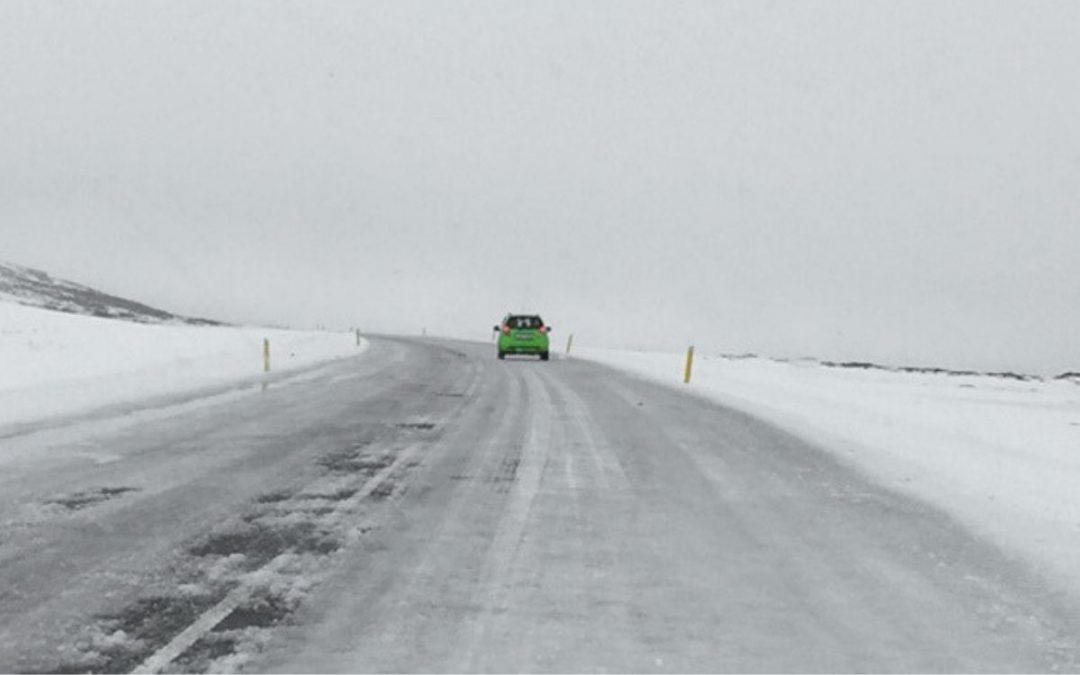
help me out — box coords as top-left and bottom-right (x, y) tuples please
(0, 339), (1080, 672)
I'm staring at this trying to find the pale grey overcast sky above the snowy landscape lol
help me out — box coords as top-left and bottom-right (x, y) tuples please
(0, 0), (1080, 373)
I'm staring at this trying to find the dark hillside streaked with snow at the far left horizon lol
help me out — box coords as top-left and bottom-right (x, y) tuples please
(0, 262), (218, 325)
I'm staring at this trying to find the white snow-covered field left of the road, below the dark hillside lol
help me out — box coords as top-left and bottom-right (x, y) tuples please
(0, 301), (366, 428)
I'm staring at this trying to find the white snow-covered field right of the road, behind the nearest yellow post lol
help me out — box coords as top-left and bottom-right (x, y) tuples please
(577, 349), (1080, 594)
